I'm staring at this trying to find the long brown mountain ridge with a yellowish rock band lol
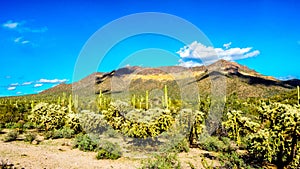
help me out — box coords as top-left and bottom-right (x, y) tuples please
(42, 60), (300, 98)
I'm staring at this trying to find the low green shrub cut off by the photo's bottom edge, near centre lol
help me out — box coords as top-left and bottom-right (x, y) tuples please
(140, 153), (181, 169)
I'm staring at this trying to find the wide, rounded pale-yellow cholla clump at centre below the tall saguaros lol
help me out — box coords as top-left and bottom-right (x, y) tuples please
(102, 101), (175, 138)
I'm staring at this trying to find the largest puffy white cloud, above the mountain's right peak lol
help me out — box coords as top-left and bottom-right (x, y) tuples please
(177, 41), (260, 67)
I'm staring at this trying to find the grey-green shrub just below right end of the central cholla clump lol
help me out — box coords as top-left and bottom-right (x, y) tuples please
(160, 135), (190, 153)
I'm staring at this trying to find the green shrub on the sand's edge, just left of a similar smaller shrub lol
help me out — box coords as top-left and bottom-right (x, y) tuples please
(74, 133), (98, 151)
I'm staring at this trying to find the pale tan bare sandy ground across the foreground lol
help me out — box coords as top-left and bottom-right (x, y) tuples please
(0, 130), (218, 169)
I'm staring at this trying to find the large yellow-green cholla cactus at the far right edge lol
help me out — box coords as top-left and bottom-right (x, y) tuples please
(248, 103), (300, 168)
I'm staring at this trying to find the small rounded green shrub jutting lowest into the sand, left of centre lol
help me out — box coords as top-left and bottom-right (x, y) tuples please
(96, 141), (122, 160)
